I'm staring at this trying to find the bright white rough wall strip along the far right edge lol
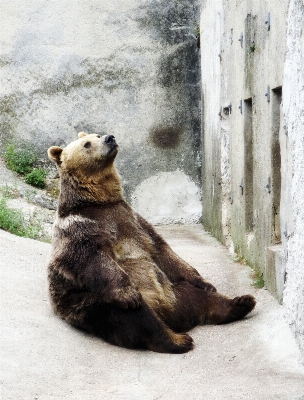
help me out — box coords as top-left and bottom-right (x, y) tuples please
(282, 0), (304, 362)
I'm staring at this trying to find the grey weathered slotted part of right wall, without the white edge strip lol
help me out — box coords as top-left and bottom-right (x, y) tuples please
(201, 0), (286, 274)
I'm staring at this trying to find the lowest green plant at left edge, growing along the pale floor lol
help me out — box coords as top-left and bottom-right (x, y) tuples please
(0, 198), (41, 239)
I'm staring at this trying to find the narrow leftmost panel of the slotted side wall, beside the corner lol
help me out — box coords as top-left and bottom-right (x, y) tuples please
(200, 0), (222, 239)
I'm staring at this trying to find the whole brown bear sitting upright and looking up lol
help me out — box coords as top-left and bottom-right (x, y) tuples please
(48, 132), (255, 353)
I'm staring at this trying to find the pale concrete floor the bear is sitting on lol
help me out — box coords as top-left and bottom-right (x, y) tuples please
(0, 225), (304, 400)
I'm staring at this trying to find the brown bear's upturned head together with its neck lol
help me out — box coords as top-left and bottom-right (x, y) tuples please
(48, 132), (123, 210)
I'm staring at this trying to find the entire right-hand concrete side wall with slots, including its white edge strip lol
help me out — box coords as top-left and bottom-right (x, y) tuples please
(200, 0), (304, 360)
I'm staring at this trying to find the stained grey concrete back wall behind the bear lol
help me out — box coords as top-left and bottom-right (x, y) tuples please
(0, 0), (201, 222)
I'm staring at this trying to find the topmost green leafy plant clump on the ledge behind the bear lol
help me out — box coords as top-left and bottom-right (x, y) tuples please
(4, 144), (37, 175)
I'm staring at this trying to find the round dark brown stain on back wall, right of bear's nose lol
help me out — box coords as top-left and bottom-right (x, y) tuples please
(149, 126), (182, 149)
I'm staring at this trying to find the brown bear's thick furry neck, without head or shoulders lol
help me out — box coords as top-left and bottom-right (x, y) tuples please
(58, 165), (124, 217)
